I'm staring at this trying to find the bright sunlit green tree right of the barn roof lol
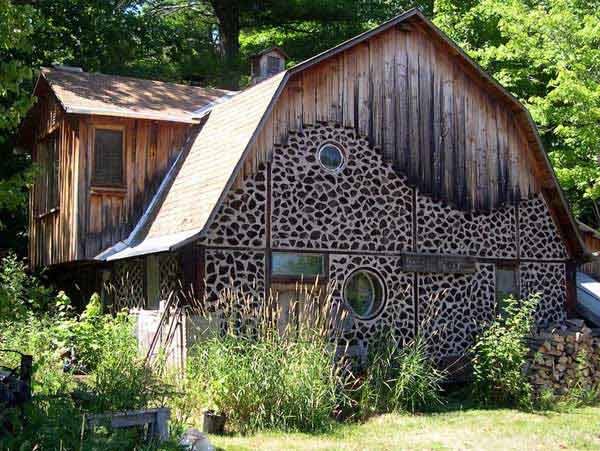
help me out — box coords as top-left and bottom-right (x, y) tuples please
(435, 0), (600, 227)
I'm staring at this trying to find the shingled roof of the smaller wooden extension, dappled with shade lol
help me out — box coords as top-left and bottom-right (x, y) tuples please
(40, 67), (234, 124)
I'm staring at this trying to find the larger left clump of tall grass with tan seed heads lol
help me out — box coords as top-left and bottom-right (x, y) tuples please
(187, 278), (346, 432)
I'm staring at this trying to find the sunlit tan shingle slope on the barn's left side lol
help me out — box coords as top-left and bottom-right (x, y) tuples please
(96, 72), (285, 260)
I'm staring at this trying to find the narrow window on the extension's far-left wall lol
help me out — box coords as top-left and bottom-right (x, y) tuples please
(36, 133), (60, 214)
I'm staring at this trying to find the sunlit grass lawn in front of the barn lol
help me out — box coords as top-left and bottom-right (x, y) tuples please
(210, 407), (600, 450)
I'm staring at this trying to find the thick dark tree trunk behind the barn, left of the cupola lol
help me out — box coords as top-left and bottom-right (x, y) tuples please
(210, 0), (240, 89)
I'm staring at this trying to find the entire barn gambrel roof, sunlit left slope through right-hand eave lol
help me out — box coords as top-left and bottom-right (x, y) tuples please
(99, 9), (587, 260)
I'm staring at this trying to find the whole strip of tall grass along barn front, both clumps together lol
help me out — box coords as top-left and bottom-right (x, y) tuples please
(177, 283), (445, 433)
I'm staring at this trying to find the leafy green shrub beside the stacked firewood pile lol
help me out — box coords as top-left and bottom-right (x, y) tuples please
(473, 295), (540, 408)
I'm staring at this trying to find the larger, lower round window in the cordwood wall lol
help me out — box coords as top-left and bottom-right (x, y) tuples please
(344, 270), (384, 318)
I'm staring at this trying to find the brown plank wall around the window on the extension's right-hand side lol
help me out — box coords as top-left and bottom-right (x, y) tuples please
(77, 116), (190, 258)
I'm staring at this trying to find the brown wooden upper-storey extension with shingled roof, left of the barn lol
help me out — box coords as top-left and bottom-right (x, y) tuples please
(21, 67), (228, 268)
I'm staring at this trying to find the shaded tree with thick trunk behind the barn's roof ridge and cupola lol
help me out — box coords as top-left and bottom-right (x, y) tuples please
(146, 0), (433, 89)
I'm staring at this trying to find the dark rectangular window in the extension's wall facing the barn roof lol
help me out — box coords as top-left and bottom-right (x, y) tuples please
(92, 128), (124, 187)
